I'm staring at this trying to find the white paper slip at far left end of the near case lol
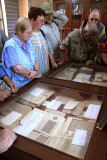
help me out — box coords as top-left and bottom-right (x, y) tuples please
(0, 111), (22, 125)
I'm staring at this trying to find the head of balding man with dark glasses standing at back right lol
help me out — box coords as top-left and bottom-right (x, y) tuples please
(88, 9), (100, 24)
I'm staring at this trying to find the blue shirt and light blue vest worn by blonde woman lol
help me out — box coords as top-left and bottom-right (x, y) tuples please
(2, 35), (38, 88)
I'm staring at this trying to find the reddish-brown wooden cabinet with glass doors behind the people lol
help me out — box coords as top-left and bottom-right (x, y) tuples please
(53, 0), (107, 37)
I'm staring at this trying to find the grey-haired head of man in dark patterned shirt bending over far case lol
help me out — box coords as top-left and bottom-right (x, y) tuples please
(83, 22), (98, 41)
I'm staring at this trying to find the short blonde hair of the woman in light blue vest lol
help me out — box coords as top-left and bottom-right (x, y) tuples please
(14, 17), (33, 33)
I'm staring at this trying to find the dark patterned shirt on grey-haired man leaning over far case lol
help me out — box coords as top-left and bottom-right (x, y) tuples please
(60, 29), (98, 63)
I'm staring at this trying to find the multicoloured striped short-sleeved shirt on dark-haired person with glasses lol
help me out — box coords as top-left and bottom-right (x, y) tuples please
(30, 31), (53, 74)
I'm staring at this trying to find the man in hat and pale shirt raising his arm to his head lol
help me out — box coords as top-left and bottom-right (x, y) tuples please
(41, 2), (68, 64)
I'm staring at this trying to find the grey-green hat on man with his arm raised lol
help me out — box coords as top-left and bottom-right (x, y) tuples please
(40, 2), (54, 14)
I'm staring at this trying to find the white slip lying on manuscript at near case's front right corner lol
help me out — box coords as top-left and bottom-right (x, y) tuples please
(72, 129), (87, 146)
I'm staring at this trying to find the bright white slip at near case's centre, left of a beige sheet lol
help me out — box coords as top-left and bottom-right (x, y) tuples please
(46, 100), (62, 110)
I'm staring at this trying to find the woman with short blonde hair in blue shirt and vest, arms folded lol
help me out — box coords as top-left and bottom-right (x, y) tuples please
(2, 17), (41, 88)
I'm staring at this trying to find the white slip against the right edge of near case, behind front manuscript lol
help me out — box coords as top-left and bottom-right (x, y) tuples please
(84, 104), (101, 119)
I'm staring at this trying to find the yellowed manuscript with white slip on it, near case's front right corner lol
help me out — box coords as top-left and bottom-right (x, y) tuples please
(48, 117), (95, 159)
